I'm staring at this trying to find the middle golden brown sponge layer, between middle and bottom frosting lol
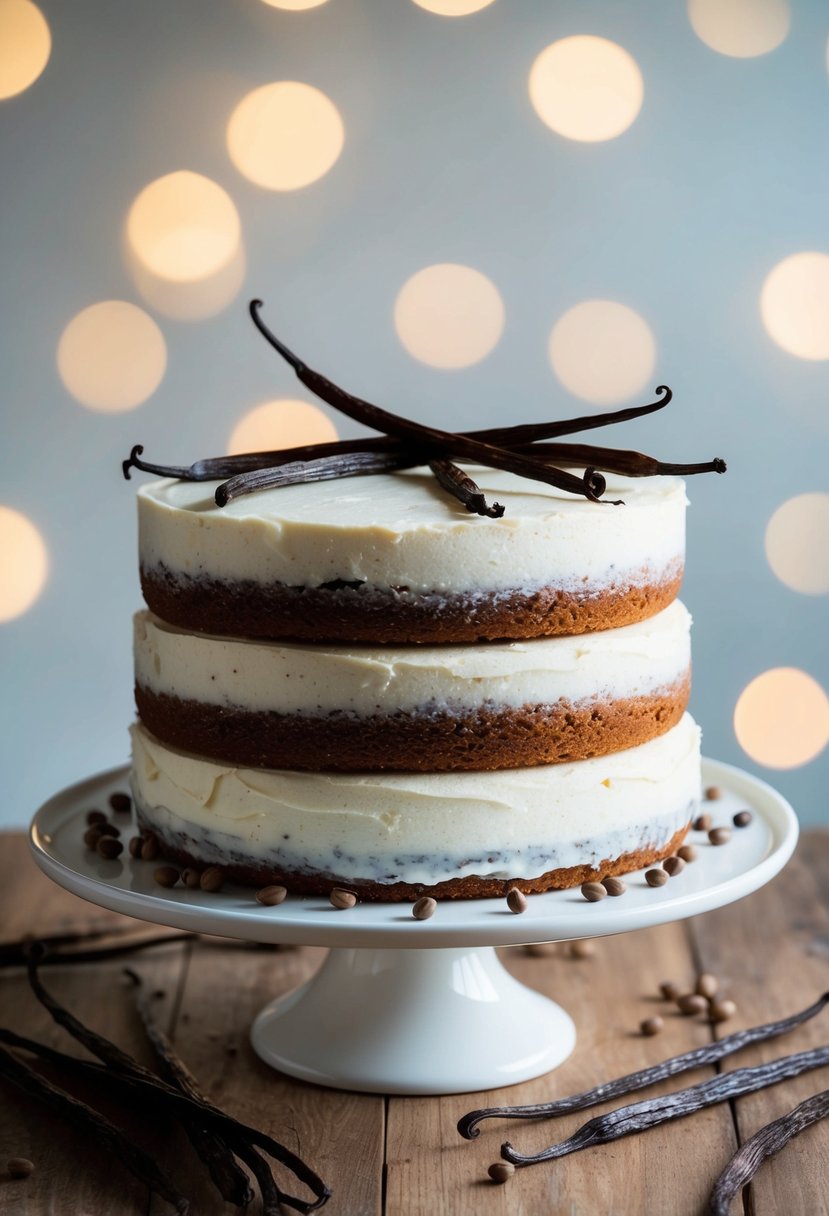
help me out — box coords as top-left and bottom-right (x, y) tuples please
(135, 677), (690, 772)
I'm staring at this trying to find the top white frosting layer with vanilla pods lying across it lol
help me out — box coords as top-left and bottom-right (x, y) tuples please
(139, 467), (687, 593)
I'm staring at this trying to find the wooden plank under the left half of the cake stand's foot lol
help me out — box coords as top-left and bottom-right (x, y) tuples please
(144, 940), (384, 1216)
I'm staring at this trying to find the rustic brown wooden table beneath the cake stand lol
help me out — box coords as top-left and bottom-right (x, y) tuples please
(0, 832), (829, 1216)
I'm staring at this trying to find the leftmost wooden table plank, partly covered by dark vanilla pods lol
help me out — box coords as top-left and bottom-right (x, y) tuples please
(0, 833), (188, 1216)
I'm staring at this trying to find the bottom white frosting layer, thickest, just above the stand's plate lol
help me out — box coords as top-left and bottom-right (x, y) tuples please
(132, 714), (700, 883)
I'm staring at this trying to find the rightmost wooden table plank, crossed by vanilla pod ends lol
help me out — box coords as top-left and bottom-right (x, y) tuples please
(694, 832), (829, 1216)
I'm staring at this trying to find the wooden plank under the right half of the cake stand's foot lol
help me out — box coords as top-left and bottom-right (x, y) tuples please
(387, 924), (735, 1216)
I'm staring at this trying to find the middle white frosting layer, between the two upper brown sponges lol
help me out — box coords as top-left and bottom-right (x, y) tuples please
(134, 601), (690, 716)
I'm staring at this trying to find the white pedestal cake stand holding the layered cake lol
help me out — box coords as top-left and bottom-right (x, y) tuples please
(30, 760), (797, 1093)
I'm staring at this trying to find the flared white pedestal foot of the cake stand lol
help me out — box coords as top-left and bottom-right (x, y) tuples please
(250, 946), (576, 1093)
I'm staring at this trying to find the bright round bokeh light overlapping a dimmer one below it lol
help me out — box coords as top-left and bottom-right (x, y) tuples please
(126, 169), (241, 282)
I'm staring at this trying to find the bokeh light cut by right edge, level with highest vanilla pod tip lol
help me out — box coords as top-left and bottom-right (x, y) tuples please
(760, 252), (829, 359)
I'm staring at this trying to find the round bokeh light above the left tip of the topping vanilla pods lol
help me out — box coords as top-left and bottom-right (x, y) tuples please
(57, 300), (167, 413)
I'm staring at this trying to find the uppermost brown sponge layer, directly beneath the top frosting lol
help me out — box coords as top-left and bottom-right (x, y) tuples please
(141, 567), (682, 644)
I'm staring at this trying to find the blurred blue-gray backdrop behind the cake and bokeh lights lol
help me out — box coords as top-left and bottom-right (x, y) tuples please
(0, 0), (829, 826)
